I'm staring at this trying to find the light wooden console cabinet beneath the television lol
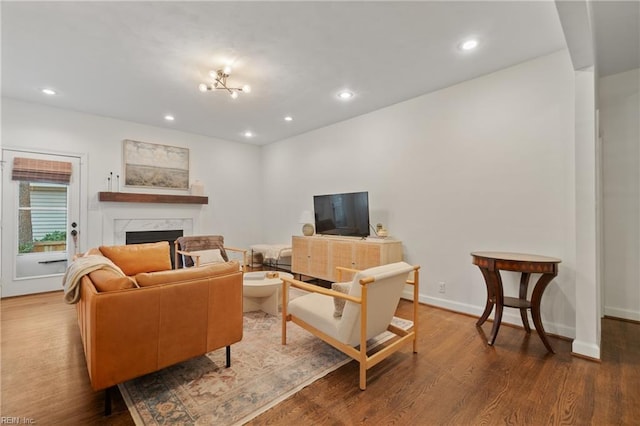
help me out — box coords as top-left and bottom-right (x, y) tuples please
(291, 236), (402, 281)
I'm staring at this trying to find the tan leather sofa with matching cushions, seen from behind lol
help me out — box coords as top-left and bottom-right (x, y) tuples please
(77, 242), (242, 390)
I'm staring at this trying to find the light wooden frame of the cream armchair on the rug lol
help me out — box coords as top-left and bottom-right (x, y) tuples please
(282, 266), (420, 390)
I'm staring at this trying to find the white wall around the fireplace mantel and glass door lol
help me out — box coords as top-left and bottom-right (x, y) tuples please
(2, 98), (262, 250)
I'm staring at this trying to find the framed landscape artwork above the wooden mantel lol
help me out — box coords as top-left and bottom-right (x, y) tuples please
(122, 139), (189, 189)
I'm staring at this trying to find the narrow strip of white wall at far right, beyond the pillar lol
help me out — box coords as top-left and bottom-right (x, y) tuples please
(599, 69), (640, 321)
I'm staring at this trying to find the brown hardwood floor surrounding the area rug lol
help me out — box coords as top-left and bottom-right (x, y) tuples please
(0, 293), (640, 425)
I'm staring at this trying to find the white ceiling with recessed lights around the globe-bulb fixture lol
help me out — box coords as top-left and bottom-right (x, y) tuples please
(1, 1), (638, 145)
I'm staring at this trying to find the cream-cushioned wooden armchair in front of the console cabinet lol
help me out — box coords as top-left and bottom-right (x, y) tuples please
(282, 262), (420, 390)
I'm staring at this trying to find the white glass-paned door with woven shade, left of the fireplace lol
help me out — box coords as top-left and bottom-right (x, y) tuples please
(0, 149), (80, 297)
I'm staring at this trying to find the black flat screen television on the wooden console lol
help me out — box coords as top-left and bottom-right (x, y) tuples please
(313, 191), (369, 237)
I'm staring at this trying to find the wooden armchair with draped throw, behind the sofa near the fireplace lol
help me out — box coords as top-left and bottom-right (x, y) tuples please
(173, 235), (247, 270)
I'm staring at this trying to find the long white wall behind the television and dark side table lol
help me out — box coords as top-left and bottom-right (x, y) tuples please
(263, 51), (576, 336)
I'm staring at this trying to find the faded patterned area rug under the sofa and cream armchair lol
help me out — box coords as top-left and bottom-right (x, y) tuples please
(119, 311), (412, 426)
